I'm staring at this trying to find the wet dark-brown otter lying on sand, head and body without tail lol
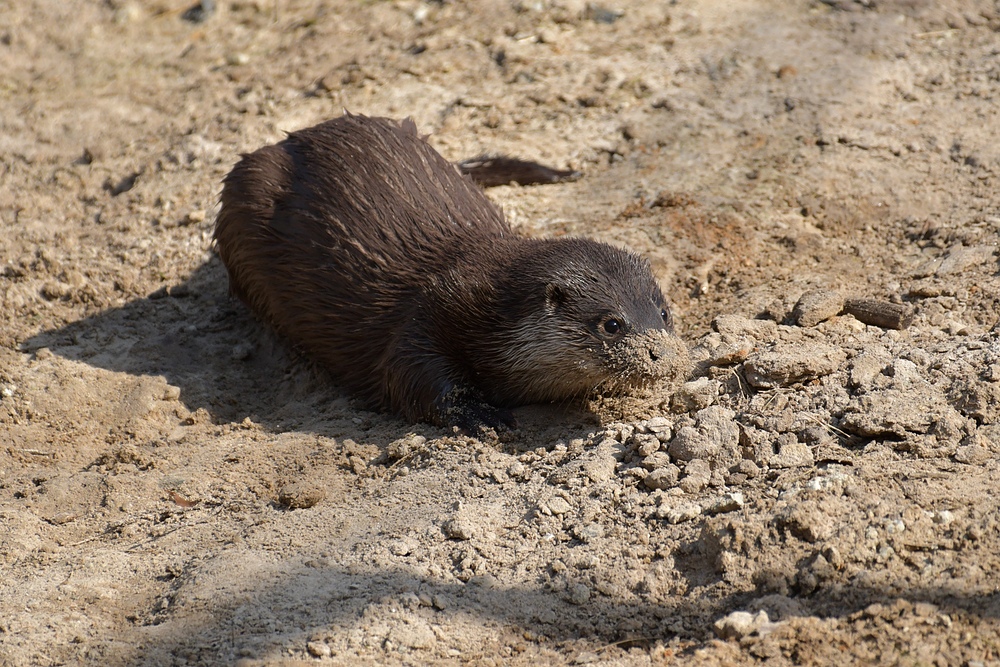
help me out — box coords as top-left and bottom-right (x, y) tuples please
(215, 114), (683, 431)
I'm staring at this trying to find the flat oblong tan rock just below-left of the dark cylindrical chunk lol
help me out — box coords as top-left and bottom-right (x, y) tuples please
(743, 343), (847, 389)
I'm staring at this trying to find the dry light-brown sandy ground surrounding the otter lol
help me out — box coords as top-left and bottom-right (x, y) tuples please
(0, 0), (1000, 666)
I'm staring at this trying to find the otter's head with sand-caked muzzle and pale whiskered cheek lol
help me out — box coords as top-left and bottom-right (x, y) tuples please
(490, 239), (688, 402)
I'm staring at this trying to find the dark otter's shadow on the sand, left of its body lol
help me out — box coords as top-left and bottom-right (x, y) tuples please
(21, 257), (368, 436)
